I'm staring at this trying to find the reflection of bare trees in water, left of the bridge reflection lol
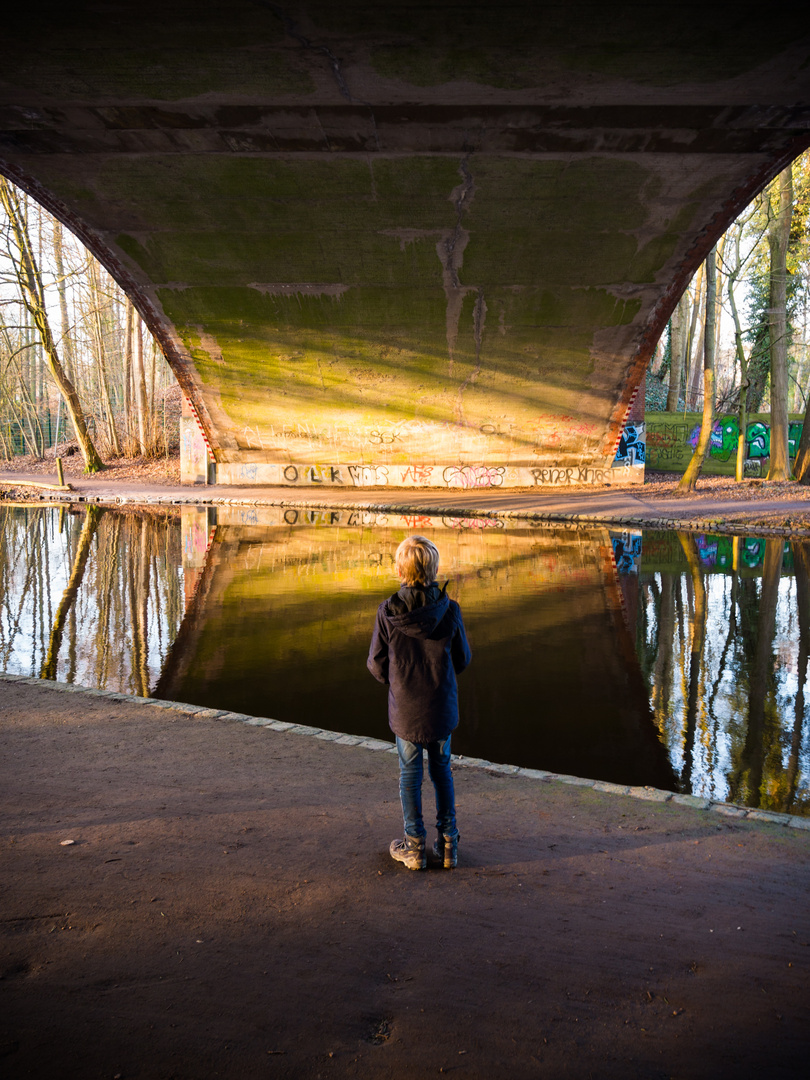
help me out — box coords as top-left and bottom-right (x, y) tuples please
(0, 504), (183, 694)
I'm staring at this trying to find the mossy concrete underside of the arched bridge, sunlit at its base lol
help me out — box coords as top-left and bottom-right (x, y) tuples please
(0, 0), (810, 486)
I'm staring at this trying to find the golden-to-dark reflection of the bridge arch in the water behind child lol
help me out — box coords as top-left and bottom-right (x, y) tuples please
(154, 507), (674, 788)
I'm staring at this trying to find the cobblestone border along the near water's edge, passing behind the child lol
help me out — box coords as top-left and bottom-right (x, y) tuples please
(0, 672), (810, 832)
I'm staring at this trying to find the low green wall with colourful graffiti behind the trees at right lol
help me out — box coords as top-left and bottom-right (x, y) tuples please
(646, 413), (804, 476)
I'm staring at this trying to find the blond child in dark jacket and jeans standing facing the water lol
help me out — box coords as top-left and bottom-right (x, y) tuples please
(368, 536), (472, 870)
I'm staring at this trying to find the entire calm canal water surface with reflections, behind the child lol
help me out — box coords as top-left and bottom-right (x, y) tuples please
(0, 505), (810, 814)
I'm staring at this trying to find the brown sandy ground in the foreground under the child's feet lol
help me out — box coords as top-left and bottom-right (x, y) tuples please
(0, 681), (810, 1080)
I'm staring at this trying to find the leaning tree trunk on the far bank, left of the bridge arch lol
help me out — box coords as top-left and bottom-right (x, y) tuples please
(0, 177), (104, 473)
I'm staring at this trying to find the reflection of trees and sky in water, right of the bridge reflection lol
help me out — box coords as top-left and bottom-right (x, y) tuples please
(636, 532), (810, 813)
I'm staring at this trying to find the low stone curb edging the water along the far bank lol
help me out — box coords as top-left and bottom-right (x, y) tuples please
(1, 483), (810, 537)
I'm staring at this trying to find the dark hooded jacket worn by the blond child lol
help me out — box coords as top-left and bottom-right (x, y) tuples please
(368, 581), (472, 743)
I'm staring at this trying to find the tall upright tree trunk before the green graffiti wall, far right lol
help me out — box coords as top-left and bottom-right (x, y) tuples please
(767, 165), (793, 480)
